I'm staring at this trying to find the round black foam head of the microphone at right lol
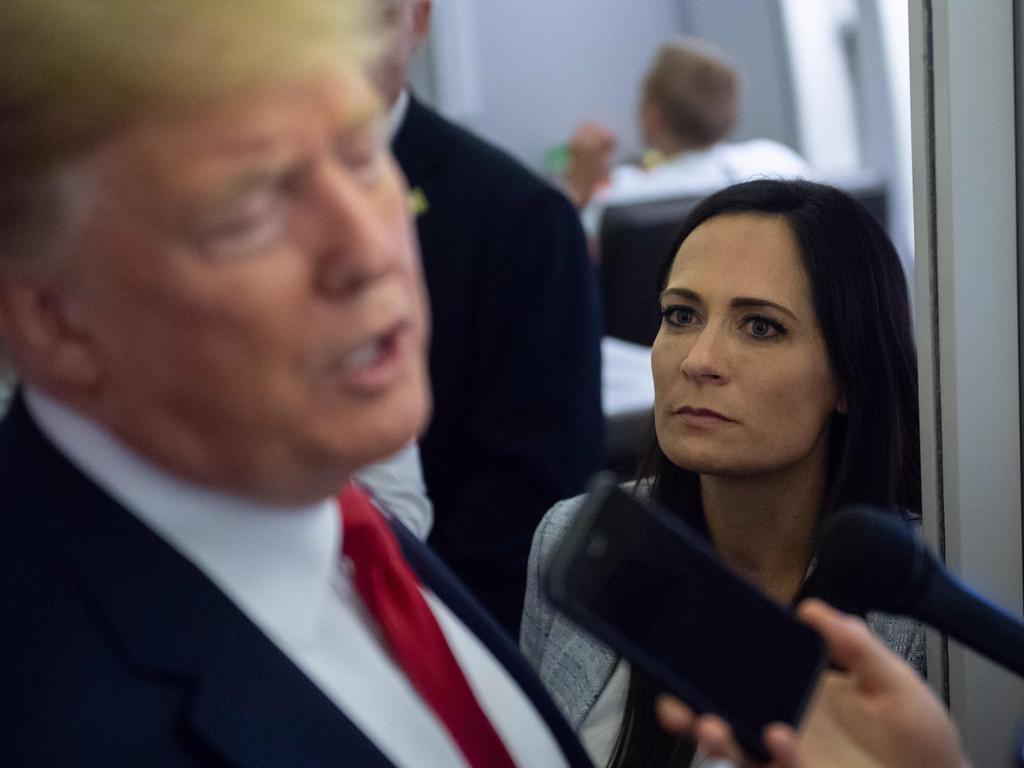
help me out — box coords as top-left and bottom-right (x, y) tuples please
(816, 505), (924, 611)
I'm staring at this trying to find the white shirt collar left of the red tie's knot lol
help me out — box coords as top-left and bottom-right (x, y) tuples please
(25, 387), (341, 647)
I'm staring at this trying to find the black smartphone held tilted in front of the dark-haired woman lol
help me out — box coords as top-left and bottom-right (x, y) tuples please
(545, 476), (826, 759)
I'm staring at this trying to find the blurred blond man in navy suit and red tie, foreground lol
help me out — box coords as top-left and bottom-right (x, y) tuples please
(0, 0), (587, 768)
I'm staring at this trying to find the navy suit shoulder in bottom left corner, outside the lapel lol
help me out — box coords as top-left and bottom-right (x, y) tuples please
(0, 509), (209, 766)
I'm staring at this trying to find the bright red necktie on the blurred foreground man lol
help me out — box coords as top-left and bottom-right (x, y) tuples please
(338, 483), (515, 768)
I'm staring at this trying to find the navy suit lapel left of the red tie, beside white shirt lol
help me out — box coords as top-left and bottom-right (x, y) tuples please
(0, 397), (391, 768)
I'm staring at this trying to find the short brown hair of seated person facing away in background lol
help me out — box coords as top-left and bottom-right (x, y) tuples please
(643, 37), (739, 146)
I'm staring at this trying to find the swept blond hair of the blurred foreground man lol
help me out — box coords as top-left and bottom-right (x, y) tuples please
(0, 0), (377, 246)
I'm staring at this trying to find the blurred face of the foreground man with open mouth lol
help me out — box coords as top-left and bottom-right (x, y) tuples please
(50, 70), (429, 503)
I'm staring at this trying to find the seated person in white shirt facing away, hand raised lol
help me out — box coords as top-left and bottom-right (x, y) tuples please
(565, 37), (811, 237)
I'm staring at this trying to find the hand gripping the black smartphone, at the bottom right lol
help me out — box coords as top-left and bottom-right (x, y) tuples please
(657, 600), (968, 768)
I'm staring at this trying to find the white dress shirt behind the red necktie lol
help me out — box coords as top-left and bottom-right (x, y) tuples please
(26, 389), (565, 768)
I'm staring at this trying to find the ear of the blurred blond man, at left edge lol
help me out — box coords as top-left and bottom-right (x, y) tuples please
(0, 275), (100, 394)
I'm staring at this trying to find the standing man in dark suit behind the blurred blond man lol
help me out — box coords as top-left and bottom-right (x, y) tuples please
(375, 0), (603, 636)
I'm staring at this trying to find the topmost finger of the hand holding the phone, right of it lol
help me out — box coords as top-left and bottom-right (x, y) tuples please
(797, 598), (900, 687)
